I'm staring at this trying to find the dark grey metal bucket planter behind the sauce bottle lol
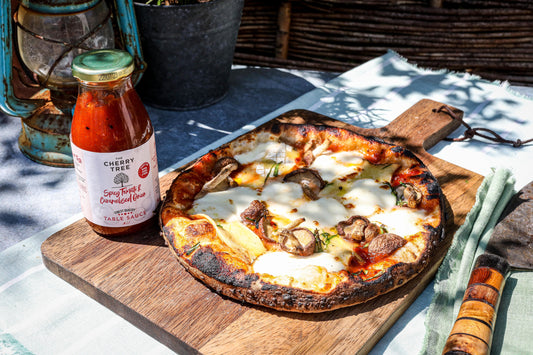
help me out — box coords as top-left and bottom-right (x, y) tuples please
(134, 0), (244, 110)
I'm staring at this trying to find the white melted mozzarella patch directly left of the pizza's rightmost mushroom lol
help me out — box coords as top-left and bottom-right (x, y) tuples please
(343, 179), (396, 216)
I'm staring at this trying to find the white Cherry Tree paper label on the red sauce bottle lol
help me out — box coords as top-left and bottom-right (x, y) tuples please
(71, 134), (160, 227)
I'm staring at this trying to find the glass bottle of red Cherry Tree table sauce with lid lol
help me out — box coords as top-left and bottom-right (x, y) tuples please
(70, 49), (161, 236)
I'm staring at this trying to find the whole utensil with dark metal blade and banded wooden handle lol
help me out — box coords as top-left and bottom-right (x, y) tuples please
(442, 181), (533, 355)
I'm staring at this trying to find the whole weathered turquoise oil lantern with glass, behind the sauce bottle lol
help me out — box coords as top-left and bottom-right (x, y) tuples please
(0, 0), (145, 167)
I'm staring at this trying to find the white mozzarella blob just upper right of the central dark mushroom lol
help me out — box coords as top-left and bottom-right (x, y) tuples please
(310, 151), (364, 181)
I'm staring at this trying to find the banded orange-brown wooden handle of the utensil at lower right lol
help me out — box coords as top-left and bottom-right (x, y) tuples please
(442, 254), (509, 355)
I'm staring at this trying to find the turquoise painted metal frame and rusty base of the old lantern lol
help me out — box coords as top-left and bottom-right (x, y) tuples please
(0, 0), (146, 167)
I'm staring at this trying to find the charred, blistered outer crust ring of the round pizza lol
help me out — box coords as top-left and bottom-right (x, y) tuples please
(160, 121), (444, 313)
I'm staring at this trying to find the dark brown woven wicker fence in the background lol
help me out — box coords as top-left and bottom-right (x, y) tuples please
(234, 0), (533, 86)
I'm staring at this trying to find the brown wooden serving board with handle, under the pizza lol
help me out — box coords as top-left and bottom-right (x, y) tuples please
(41, 100), (483, 355)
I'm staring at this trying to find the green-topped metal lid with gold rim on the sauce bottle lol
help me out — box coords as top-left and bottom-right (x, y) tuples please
(72, 49), (135, 83)
